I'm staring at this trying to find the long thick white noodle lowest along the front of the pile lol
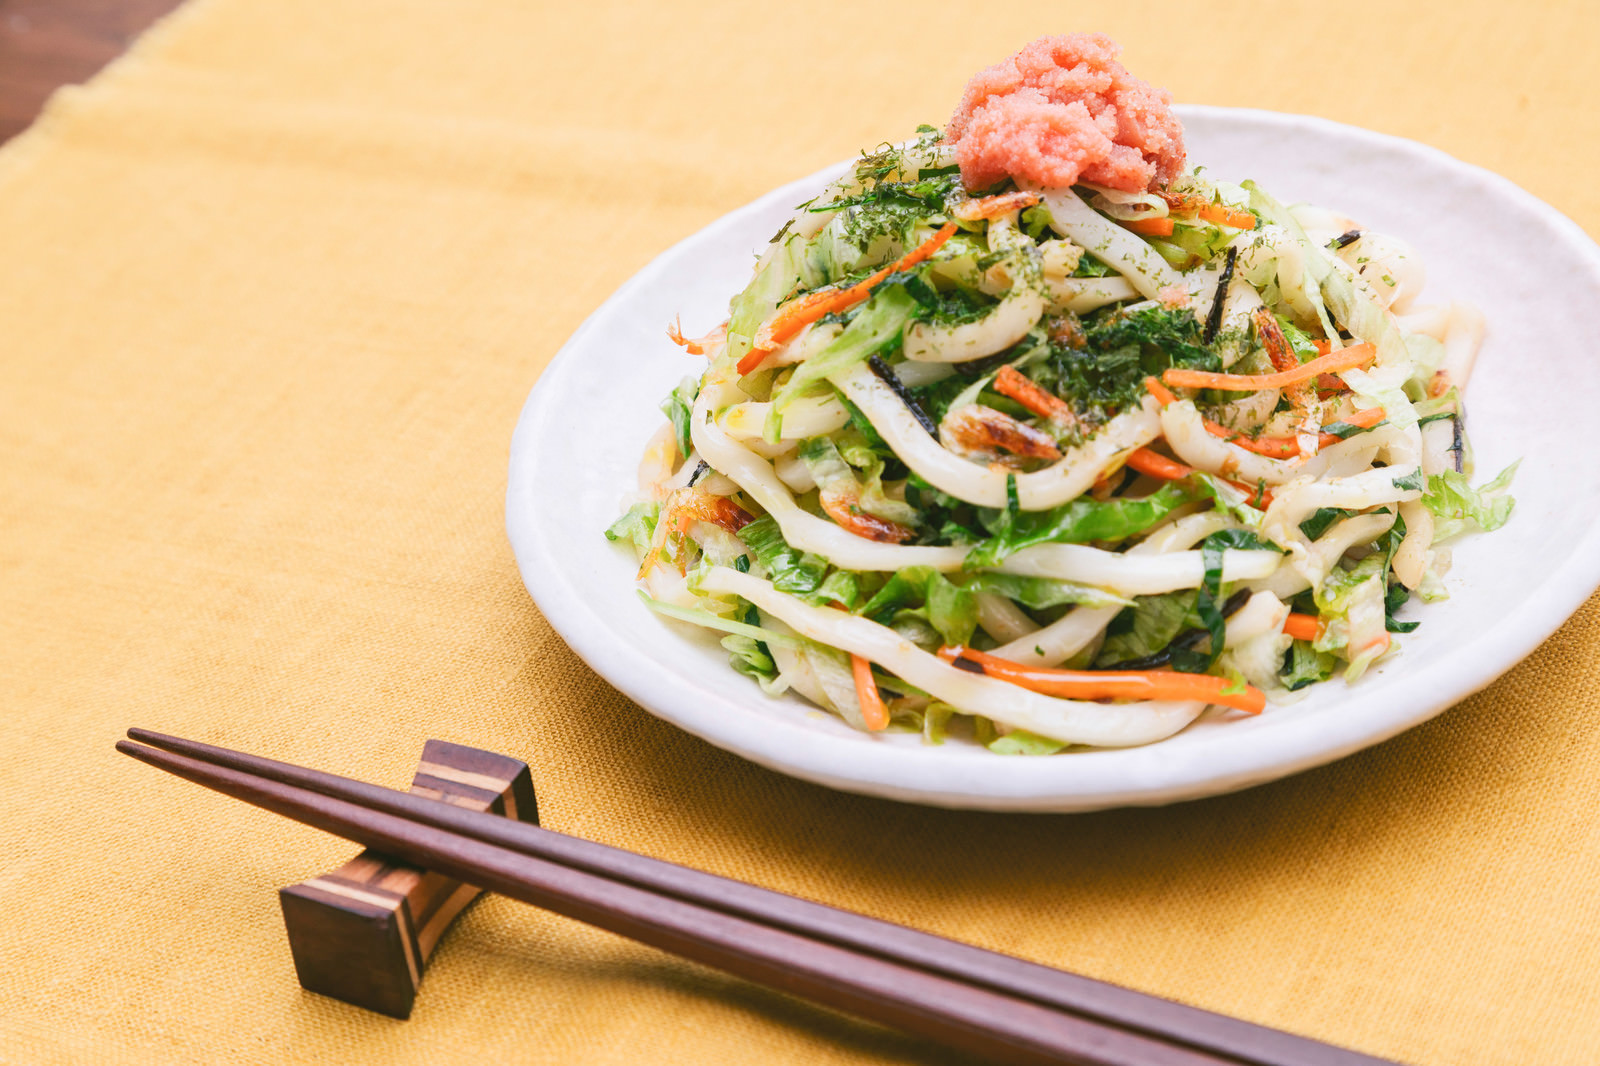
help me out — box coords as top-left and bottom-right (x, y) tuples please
(699, 567), (1205, 747)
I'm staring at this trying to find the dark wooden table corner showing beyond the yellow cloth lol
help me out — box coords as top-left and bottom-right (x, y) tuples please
(0, 0), (181, 141)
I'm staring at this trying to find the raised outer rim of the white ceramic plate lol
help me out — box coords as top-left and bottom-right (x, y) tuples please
(506, 104), (1600, 812)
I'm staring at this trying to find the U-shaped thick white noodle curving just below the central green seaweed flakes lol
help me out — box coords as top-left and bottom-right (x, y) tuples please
(832, 358), (1162, 511)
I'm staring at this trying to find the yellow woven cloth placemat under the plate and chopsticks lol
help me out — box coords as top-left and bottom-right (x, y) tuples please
(0, 0), (1600, 1066)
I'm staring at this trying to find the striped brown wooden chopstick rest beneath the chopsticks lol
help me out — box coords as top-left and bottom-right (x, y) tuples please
(278, 739), (539, 1018)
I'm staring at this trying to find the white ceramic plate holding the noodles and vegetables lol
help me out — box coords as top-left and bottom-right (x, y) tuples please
(506, 107), (1600, 812)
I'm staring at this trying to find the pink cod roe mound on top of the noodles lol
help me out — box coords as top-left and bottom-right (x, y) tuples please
(944, 34), (1184, 192)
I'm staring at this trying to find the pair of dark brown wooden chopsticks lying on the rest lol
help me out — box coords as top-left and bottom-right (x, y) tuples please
(117, 728), (1384, 1066)
